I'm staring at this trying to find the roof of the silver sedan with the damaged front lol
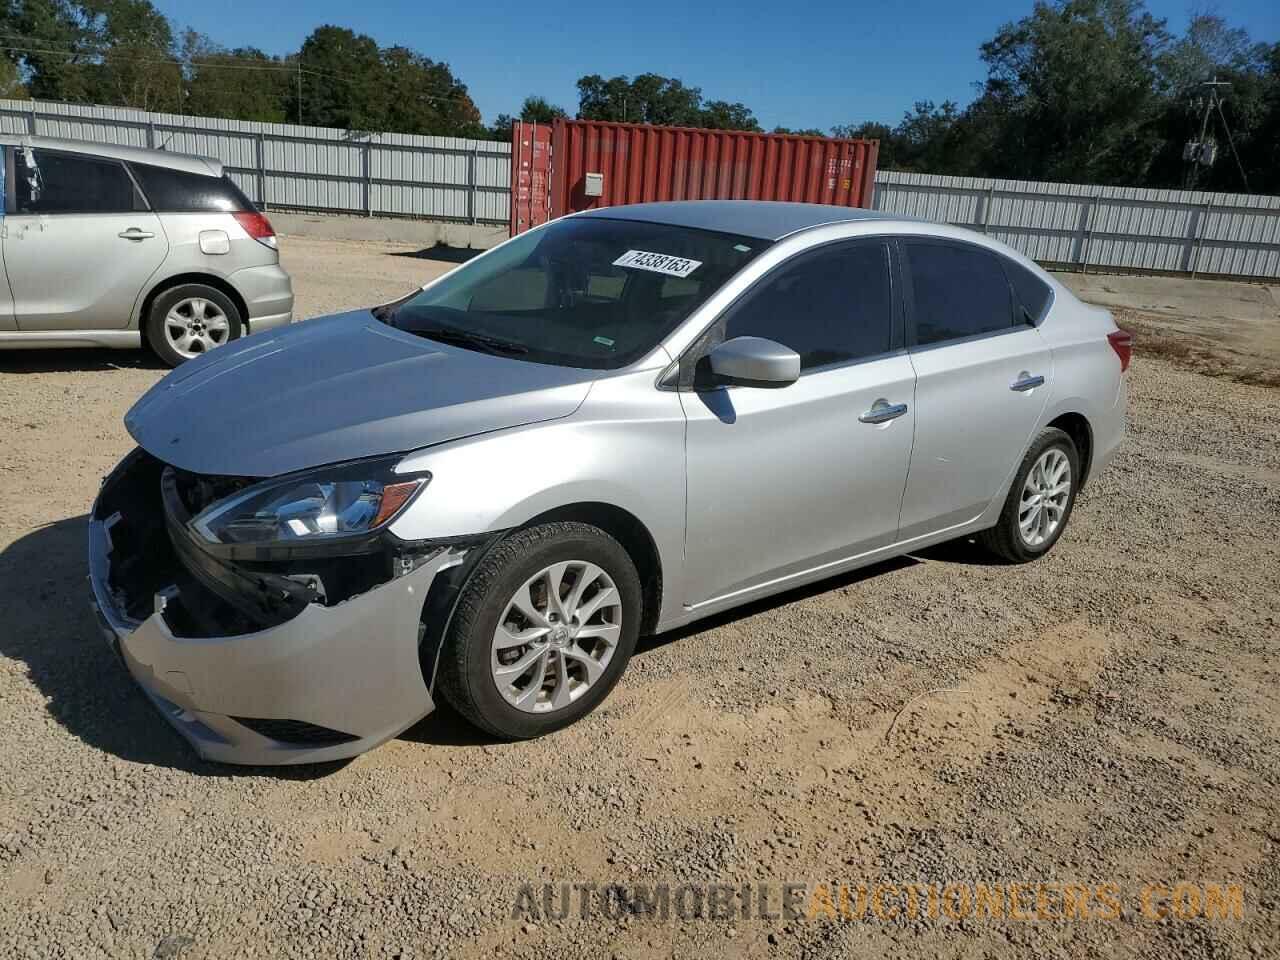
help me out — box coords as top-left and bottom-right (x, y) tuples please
(575, 200), (919, 241)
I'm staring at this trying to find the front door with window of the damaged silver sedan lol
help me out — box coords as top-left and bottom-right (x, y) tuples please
(681, 239), (915, 607)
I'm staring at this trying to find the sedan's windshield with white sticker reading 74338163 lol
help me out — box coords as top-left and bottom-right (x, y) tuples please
(388, 218), (769, 370)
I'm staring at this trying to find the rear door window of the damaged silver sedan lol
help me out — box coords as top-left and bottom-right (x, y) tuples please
(906, 242), (1014, 344)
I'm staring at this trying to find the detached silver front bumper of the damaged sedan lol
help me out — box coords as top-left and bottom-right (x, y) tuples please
(88, 458), (465, 764)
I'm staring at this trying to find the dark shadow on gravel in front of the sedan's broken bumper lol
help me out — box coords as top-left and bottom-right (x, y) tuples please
(0, 516), (348, 780)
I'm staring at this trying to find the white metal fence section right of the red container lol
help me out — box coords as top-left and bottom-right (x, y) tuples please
(874, 170), (1280, 278)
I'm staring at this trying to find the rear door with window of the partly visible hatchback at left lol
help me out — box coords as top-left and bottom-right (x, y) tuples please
(4, 146), (168, 330)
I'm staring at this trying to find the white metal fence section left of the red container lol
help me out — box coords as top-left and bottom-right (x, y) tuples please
(0, 100), (511, 224)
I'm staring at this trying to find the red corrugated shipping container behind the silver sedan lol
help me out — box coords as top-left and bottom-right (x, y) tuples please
(511, 120), (879, 236)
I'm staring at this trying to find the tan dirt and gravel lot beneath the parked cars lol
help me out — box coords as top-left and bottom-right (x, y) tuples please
(0, 239), (1280, 960)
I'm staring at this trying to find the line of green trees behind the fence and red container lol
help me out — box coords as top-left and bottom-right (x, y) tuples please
(0, 0), (1280, 193)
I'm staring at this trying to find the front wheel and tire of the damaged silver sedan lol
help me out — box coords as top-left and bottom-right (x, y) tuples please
(436, 522), (643, 740)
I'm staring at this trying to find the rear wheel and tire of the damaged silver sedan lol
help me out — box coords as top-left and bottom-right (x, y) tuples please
(978, 426), (1080, 563)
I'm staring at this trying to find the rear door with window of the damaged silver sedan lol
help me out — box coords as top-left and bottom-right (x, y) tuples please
(899, 238), (1053, 540)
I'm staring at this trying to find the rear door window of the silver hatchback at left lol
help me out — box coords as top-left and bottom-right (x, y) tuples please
(13, 147), (145, 214)
